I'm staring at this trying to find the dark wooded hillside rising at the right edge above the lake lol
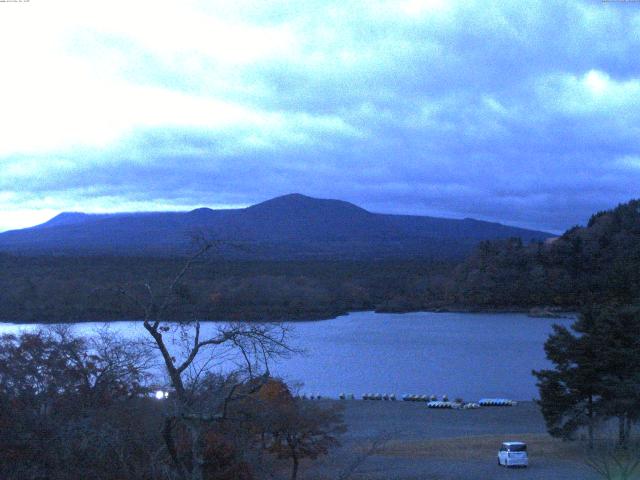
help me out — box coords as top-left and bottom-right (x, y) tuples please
(444, 200), (640, 308)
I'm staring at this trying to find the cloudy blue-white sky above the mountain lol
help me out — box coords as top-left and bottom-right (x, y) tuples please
(0, 0), (640, 232)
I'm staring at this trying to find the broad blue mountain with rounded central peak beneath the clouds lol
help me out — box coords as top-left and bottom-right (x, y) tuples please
(0, 194), (551, 259)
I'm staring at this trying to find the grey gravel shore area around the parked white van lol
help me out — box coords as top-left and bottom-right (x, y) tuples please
(303, 400), (598, 480)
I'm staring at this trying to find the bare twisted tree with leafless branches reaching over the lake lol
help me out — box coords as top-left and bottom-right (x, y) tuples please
(120, 244), (293, 480)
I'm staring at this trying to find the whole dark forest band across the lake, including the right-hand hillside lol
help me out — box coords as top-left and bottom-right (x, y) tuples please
(0, 200), (640, 323)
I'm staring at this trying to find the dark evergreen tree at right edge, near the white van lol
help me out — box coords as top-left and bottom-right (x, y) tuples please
(533, 307), (640, 447)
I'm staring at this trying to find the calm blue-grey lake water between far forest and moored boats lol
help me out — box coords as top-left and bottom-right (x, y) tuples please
(0, 312), (571, 400)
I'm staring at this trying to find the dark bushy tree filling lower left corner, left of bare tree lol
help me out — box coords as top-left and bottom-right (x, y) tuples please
(0, 329), (160, 480)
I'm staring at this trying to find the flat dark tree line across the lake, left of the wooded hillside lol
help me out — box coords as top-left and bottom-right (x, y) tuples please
(0, 254), (451, 323)
